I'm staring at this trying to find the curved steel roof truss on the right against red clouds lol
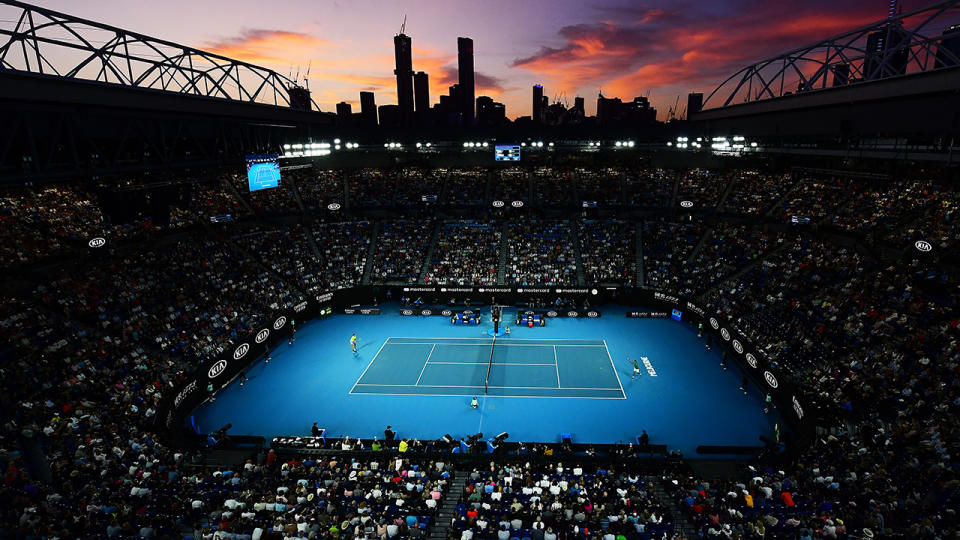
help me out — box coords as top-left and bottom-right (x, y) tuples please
(703, 0), (960, 109)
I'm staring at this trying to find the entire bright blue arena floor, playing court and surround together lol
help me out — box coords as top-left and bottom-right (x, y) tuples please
(195, 306), (783, 457)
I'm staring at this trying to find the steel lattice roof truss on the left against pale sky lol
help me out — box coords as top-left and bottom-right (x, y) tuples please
(0, 0), (320, 111)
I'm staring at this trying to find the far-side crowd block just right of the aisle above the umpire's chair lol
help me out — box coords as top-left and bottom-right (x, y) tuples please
(503, 219), (577, 286)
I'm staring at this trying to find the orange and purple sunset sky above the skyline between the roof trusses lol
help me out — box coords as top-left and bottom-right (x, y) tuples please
(30, 0), (927, 120)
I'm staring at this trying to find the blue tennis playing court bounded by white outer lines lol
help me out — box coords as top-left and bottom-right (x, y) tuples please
(350, 337), (626, 399)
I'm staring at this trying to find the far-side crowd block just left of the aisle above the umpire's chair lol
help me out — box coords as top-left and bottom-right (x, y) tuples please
(424, 220), (503, 285)
